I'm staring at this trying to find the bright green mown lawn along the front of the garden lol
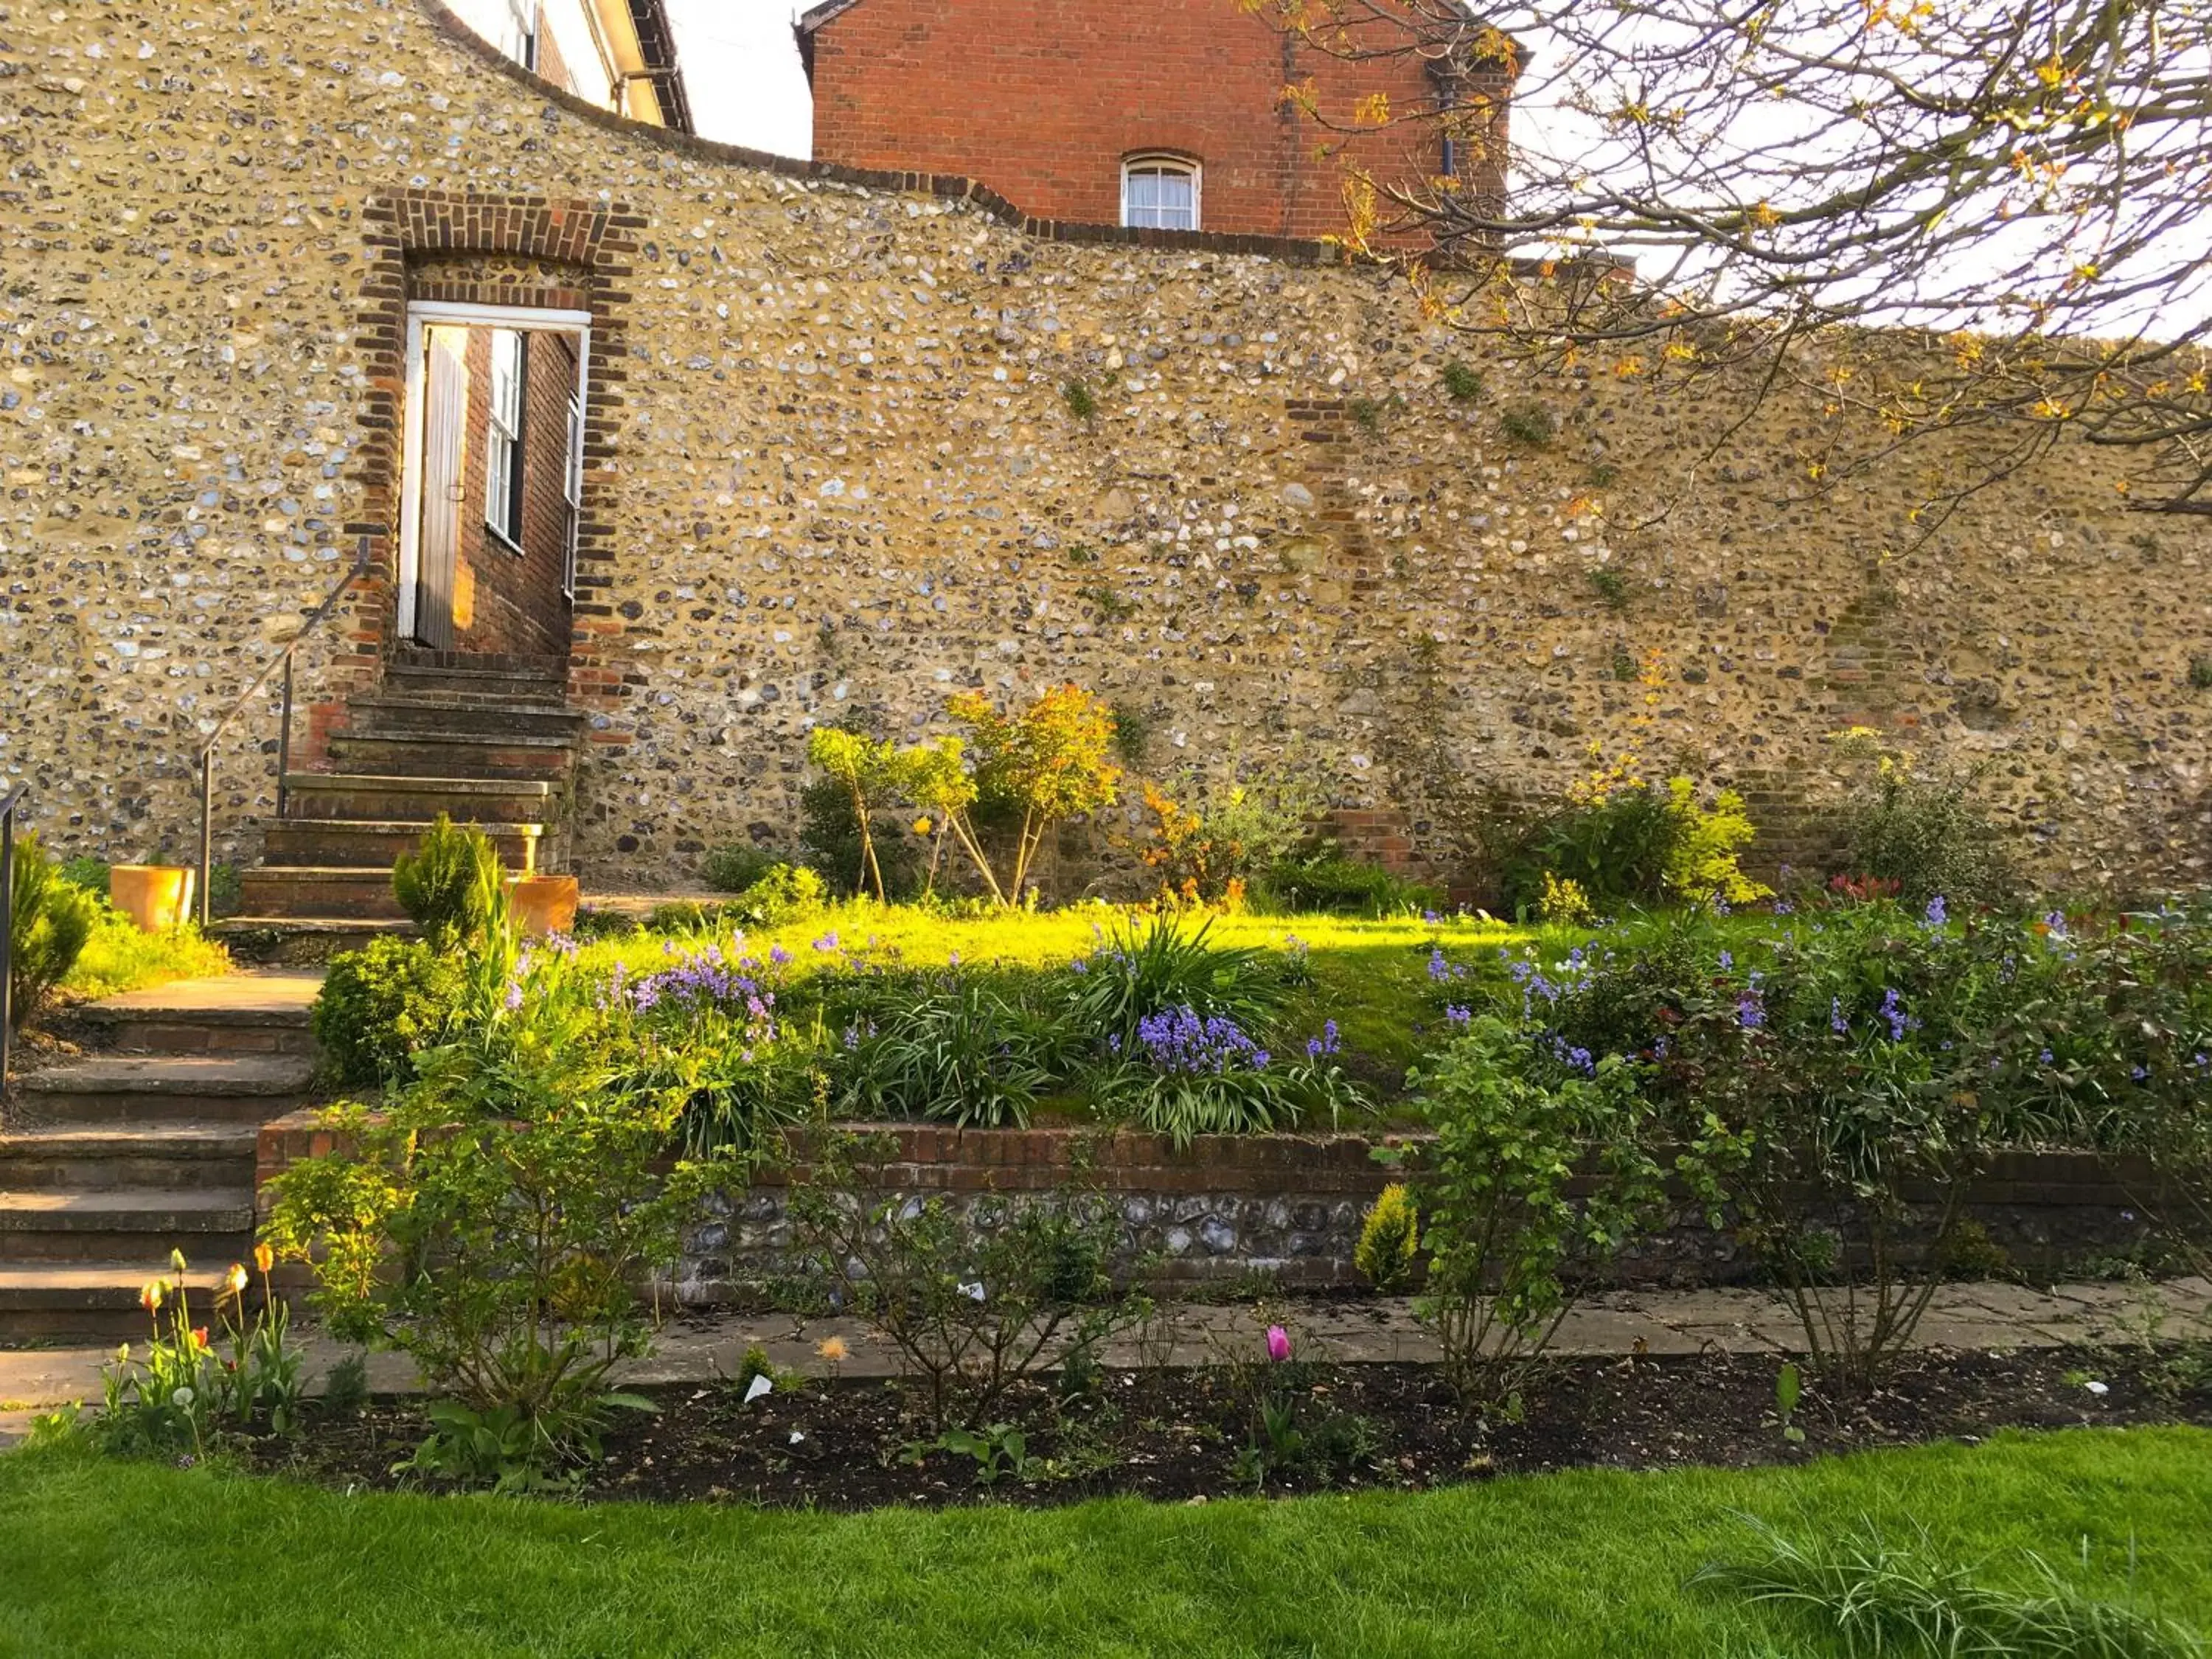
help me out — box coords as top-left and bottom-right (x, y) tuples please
(0, 1429), (2212, 1659)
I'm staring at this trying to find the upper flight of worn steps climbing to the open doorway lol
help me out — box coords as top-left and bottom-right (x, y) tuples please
(226, 650), (586, 931)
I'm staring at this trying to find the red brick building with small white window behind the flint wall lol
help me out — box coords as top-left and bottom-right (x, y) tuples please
(796, 0), (1511, 237)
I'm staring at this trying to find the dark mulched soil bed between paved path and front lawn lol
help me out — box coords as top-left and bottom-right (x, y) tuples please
(248, 1352), (2212, 1509)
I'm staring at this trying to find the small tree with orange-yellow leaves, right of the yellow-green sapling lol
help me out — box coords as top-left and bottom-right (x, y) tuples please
(949, 686), (1121, 902)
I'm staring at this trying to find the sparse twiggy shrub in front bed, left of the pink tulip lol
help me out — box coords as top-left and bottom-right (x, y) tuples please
(792, 1128), (1150, 1431)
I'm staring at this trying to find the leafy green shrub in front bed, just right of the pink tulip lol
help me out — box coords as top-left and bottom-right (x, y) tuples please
(1411, 1015), (1666, 1405)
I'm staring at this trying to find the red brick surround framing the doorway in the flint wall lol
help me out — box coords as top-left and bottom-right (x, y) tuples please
(341, 190), (644, 734)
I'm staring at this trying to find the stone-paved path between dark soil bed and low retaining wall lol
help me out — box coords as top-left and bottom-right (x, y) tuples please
(0, 1279), (2212, 1444)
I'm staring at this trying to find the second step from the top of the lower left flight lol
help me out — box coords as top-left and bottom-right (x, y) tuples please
(9, 1055), (314, 1130)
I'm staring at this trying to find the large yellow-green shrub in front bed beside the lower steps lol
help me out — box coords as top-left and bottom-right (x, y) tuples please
(268, 947), (730, 1489)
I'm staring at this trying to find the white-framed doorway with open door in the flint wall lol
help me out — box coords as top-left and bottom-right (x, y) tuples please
(396, 301), (591, 657)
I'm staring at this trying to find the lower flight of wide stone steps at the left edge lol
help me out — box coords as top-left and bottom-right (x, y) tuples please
(0, 973), (316, 1345)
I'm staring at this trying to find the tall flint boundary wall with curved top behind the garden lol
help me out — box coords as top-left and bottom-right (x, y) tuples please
(0, 0), (2212, 887)
